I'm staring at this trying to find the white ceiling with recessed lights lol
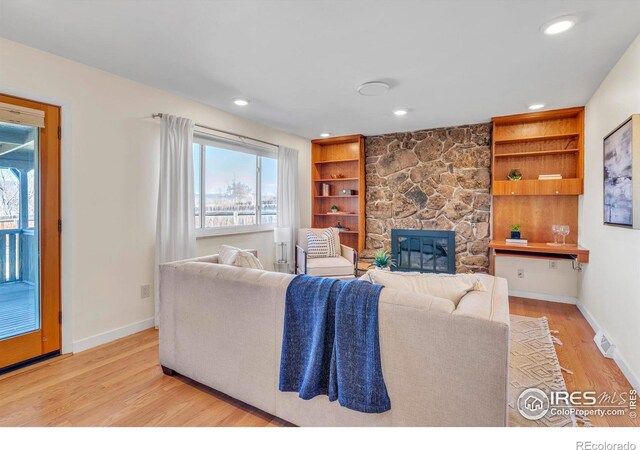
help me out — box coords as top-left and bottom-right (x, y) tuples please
(0, 0), (640, 138)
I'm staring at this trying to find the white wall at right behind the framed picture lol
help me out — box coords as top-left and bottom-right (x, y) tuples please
(578, 37), (640, 389)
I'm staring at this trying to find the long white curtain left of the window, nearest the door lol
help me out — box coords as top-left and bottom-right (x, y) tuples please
(155, 114), (196, 326)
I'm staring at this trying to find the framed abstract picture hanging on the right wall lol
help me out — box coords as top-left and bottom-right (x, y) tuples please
(603, 114), (640, 229)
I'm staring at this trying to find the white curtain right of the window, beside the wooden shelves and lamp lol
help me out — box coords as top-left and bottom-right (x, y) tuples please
(278, 146), (300, 265)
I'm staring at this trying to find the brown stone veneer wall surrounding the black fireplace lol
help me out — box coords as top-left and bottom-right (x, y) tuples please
(361, 123), (491, 272)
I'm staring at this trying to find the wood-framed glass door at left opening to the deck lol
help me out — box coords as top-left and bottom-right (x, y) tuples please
(0, 94), (61, 373)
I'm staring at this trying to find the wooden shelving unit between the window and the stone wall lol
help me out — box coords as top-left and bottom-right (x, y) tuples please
(311, 134), (365, 252)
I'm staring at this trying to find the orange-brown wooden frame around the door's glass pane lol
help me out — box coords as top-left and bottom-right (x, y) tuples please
(0, 94), (62, 368)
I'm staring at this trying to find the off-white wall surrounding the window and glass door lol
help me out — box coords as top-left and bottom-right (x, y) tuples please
(0, 39), (311, 351)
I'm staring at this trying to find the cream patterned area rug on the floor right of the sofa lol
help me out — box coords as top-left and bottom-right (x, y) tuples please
(509, 314), (586, 427)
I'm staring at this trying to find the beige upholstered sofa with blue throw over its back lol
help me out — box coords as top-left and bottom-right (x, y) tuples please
(160, 255), (509, 426)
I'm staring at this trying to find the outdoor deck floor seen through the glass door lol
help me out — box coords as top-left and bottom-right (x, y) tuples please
(0, 282), (40, 339)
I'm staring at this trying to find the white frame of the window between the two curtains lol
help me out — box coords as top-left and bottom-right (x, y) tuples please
(193, 133), (278, 238)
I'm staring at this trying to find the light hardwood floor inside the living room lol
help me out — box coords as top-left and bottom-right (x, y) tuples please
(0, 298), (638, 426)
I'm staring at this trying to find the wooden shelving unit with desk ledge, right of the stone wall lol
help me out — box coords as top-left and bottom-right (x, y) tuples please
(490, 107), (589, 270)
